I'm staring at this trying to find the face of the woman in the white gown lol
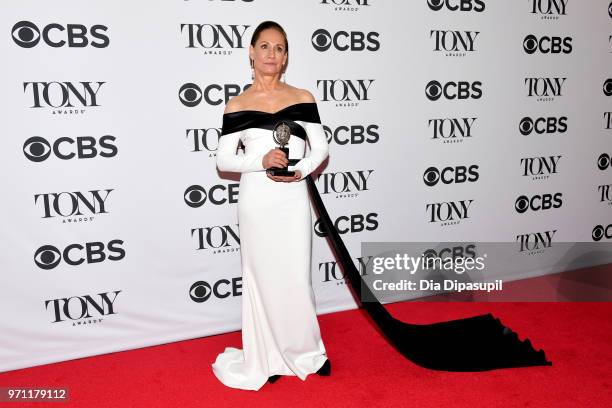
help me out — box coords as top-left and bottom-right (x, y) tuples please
(249, 28), (287, 75)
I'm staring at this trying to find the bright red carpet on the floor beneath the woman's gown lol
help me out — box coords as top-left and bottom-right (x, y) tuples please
(0, 302), (612, 408)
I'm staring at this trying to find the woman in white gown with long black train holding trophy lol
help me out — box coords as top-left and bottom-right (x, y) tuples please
(213, 22), (552, 396)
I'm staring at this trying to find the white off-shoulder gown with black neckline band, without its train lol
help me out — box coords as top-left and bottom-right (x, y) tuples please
(212, 102), (328, 390)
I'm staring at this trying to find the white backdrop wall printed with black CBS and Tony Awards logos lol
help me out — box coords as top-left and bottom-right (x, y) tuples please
(0, 0), (612, 371)
